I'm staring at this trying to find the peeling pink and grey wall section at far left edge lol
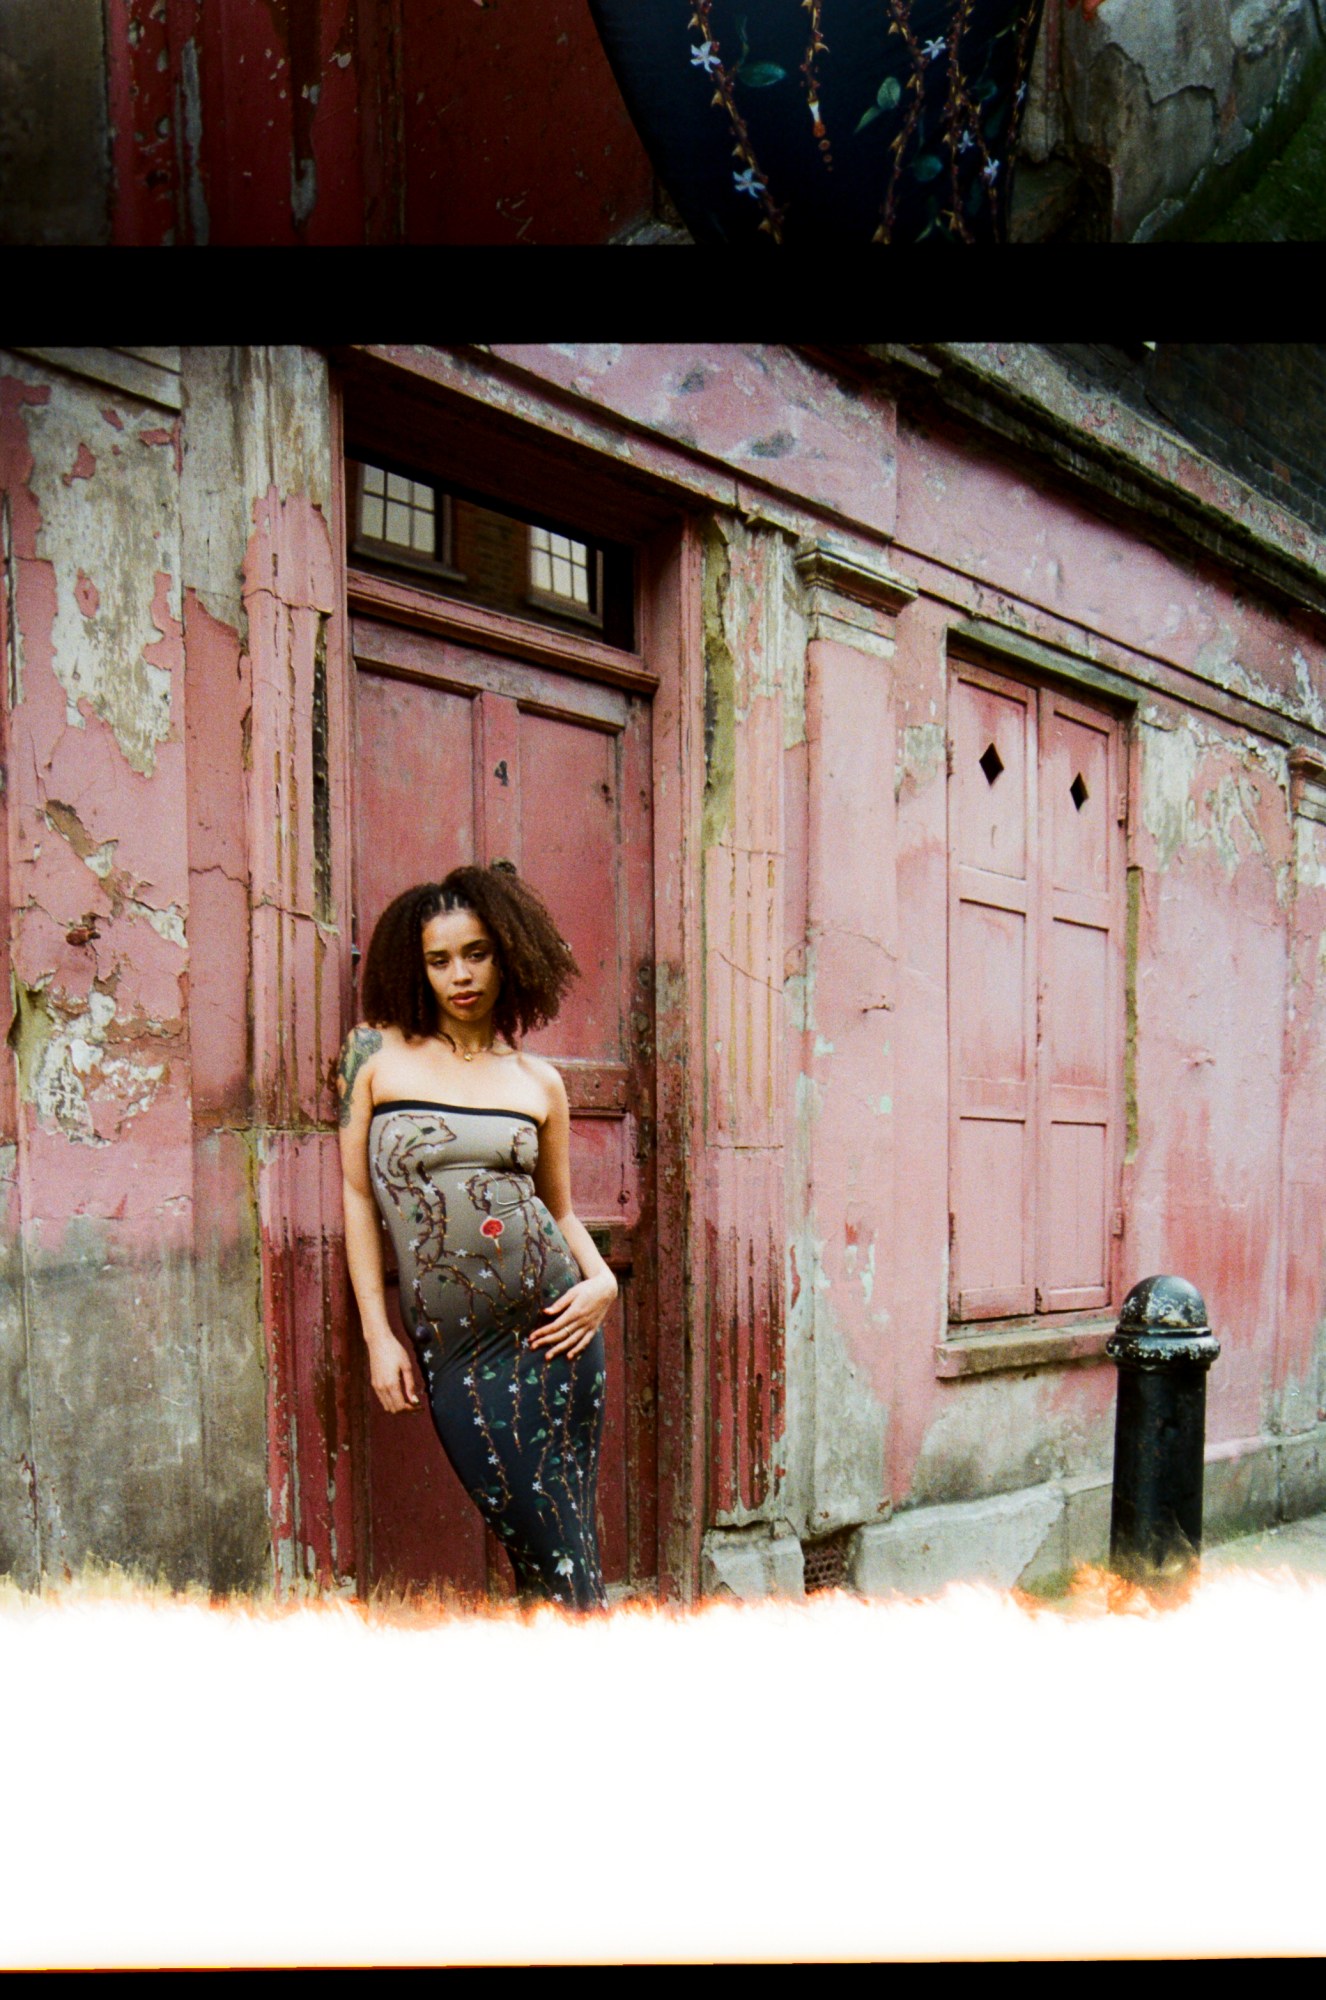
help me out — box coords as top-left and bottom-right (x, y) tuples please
(2, 360), (208, 1578)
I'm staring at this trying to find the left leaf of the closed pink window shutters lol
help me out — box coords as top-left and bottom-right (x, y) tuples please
(948, 666), (1036, 1320)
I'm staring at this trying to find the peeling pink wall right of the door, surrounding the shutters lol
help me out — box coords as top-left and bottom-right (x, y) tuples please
(482, 348), (1326, 1588)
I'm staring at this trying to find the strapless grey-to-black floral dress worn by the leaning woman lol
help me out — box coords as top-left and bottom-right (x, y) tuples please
(368, 1102), (606, 1610)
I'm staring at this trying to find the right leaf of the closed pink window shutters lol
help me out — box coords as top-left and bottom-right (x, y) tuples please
(1036, 688), (1124, 1312)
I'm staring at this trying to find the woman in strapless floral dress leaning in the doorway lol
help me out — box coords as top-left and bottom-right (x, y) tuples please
(340, 866), (616, 1610)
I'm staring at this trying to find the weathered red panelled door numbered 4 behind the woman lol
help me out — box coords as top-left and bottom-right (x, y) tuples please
(354, 618), (658, 1590)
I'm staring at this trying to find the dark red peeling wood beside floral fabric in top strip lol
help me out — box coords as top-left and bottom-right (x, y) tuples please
(106, 0), (654, 246)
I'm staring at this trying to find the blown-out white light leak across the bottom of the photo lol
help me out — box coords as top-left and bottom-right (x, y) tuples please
(0, 1574), (1326, 1966)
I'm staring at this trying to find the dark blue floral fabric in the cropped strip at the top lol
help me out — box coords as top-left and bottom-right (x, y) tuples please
(590, 0), (1044, 248)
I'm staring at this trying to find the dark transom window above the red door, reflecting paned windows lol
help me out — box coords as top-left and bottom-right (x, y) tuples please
(346, 460), (634, 648)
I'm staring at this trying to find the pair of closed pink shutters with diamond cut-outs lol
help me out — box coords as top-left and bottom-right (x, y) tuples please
(948, 666), (1124, 1320)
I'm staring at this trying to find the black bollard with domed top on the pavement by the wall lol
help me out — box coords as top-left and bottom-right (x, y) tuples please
(1106, 1278), (1220, 1598)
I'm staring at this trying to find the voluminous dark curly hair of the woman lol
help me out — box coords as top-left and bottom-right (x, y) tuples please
(362, 862), (580, 1044)
